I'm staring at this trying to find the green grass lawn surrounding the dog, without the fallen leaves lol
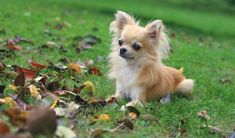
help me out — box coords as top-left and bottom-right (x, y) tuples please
(0, 0), (235, 137)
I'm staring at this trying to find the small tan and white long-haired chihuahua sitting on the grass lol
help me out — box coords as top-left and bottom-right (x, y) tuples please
(109, 11), (194, 110)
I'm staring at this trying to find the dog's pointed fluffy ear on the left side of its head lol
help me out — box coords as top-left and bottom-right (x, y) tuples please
(109, 11), (136, 34)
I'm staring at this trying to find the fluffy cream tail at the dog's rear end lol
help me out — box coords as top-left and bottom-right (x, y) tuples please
(176, 79), (194, 96)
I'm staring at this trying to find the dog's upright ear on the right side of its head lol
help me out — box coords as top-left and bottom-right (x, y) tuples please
(145, 20), (164, 38)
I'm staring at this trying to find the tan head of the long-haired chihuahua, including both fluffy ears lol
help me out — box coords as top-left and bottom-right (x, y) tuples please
(110, 11), (169, 61)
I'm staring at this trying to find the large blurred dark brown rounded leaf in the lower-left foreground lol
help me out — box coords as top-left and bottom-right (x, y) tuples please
(27, 107), (57, 135)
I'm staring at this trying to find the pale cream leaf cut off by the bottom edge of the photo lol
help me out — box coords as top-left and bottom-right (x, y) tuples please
(55, 126), (77, 138)
